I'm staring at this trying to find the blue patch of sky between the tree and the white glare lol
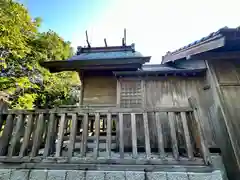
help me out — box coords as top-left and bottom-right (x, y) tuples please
(20, 0), (111, 41)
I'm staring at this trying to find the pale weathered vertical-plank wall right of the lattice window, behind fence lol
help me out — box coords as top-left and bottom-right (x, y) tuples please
(121, 76), (216, 148)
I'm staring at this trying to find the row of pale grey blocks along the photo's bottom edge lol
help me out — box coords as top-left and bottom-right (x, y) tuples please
(0, 169), (223, 180)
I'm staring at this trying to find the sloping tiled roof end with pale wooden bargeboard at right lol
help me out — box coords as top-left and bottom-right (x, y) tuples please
(162, 27), (240, 63)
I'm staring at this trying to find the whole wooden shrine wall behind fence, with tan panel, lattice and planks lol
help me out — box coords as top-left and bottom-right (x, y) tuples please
(80, 73), (216, 153)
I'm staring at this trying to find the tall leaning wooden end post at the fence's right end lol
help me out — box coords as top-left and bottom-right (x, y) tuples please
(188, 97), (211, 164)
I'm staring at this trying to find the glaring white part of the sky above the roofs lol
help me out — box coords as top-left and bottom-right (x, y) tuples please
(72, 0), (240, 63)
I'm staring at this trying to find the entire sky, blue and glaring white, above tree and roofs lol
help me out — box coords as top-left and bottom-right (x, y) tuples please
(20, 0), (240, 63)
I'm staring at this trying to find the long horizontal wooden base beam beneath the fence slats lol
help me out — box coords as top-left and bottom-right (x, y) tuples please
(0, 156), (205, 167)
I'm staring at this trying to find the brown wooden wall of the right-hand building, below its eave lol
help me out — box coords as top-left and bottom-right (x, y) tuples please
(207, 59), (240, 179)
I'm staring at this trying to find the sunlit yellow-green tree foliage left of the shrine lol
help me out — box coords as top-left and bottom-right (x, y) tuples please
(0, 0), (79, 108)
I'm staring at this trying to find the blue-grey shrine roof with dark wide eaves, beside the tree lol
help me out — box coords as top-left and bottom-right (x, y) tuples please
(41, 44), (151, 72)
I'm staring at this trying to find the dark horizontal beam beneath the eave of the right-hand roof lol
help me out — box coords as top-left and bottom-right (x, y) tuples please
(187, 51), (240, 60)
